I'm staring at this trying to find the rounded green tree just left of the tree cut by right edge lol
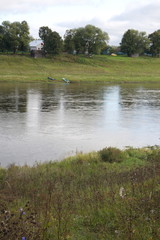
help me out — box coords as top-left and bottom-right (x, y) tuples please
(121, 29), (150, 57)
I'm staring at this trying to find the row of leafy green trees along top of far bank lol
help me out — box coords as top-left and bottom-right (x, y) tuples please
(0, 21), (160, 56)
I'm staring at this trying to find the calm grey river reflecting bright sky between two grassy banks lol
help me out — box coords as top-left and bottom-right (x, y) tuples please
(0, 82), (160, 166)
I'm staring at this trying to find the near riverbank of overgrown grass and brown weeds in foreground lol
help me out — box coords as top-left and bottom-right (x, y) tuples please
(0, 147), (160, 240)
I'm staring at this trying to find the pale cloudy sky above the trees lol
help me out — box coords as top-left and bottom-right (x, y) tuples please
(0, 0), (160, 45)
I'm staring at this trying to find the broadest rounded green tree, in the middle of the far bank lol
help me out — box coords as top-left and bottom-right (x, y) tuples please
(64, 25), (109, 54)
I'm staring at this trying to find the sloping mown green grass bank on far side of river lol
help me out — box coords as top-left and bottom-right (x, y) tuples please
(0, 54), (160, 82)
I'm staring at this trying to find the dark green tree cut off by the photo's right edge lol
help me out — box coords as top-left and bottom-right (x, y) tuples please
(148, 29), (160, 57)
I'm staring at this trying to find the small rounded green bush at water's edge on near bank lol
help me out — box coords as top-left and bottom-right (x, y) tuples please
(99, 147), (123, 163)
